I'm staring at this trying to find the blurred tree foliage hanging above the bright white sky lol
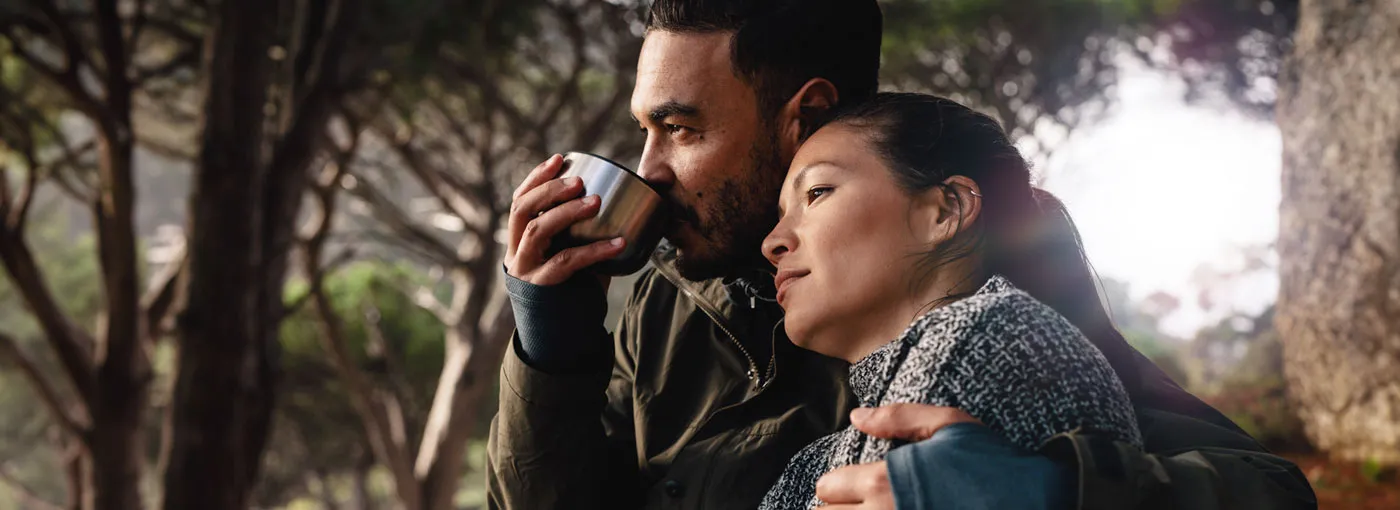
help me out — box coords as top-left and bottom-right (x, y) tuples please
(881, 0), (1298, 158)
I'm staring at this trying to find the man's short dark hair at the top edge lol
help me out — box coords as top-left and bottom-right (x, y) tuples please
(647, 0), (882, 119)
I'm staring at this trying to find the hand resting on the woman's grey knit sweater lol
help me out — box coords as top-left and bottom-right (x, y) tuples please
(816, 404), (981, 510)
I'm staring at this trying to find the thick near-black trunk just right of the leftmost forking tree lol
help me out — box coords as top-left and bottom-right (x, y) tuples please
(164, 0), (280, 510)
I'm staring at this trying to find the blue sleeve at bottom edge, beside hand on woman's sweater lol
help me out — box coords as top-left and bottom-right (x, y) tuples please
(886, 423), (1075, 510)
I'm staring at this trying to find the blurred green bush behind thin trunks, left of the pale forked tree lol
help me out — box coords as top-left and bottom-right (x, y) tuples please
(258, 262), (444, 506)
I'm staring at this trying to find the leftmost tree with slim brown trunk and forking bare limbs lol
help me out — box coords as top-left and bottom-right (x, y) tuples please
(0, 0), (195, 509)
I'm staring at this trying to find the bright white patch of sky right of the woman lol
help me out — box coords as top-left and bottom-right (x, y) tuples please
(1039, 61), (1281, 338)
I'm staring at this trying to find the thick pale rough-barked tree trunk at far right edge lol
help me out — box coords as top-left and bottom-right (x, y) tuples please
(1277, 0), (1400, 462)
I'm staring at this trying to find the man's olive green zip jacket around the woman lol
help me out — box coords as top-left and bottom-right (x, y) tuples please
(487, 253), (1316, 510)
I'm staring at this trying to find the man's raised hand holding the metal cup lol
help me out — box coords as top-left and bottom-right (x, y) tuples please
(505, 154), (623, 286)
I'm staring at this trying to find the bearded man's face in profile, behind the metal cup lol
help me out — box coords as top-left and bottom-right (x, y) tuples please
(631, 31), (788, 280)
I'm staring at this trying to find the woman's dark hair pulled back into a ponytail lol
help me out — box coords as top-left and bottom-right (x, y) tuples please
(827, 92), (1141, 401)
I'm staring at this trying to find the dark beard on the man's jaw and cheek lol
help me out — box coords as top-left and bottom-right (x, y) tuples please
(676, 130), (787, 282)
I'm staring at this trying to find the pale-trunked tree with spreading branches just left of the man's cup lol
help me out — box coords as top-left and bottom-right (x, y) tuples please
(296, 1), (640, 510)
